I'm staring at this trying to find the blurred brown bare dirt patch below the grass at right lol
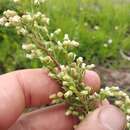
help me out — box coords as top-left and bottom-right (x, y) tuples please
(96, 67), (130, 87)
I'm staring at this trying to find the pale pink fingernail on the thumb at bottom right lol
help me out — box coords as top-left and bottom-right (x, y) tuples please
(99, 105), (126, 130)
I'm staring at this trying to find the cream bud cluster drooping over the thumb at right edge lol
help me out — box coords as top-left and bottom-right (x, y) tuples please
(97, 86), (130, 128)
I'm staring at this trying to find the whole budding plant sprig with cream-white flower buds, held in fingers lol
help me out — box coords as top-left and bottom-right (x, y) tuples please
(0, 10), (130, 129)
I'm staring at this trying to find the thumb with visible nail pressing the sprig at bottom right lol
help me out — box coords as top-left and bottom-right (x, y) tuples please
(76, 105), (126, 130)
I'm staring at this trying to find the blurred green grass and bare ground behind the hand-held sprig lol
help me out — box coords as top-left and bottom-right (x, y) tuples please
(0, 0), (130, 86)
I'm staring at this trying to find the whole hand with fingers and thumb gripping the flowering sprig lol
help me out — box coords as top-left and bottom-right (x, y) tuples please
(0, 69), (125, 130)
